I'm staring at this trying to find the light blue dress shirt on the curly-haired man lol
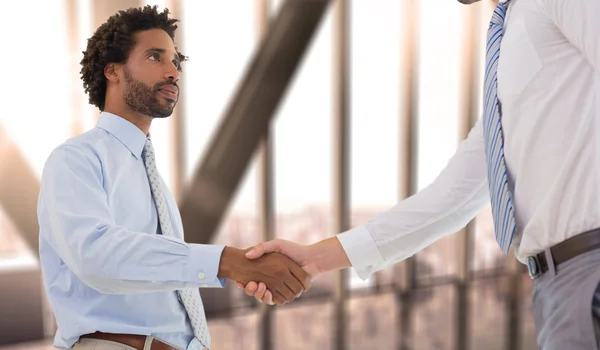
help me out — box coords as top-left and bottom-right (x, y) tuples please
(38, 113), (225, 350)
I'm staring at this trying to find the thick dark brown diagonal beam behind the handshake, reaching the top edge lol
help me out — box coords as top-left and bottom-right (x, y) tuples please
(180, 0), (329, 243)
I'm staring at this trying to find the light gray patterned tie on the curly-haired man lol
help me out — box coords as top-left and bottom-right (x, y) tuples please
(142, 137), (210, 349)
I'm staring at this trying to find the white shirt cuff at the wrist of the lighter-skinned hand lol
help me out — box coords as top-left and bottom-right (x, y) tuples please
(336, 226), (384, 280)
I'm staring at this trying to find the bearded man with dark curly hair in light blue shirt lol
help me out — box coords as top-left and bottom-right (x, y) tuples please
(38, 6), (310, 350)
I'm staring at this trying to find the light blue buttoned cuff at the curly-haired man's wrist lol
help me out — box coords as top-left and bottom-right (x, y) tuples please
(185, 243), (226, 288)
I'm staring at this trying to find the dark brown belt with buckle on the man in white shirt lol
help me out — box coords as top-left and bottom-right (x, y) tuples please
(527, 228), (600, 279)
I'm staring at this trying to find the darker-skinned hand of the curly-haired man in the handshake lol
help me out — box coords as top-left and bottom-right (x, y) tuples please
(217, 247), (311, 305)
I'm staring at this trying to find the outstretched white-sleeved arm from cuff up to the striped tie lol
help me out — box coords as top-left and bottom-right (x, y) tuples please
(338, 122), (489, 278)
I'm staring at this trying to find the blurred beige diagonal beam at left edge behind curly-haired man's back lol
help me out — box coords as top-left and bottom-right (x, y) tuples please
(0, 126), (40, 255)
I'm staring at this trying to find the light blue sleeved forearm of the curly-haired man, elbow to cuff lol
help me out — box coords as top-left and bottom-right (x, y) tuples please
(49, 219), (223, 294)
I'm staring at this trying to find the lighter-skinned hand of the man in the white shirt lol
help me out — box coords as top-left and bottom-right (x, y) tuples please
(237, 239), (322, 305)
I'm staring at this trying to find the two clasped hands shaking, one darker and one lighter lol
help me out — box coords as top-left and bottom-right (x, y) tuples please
(218, 237), (350, 305)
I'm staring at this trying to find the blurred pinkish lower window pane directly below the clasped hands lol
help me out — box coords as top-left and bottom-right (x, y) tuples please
(276, 303), (333, 350)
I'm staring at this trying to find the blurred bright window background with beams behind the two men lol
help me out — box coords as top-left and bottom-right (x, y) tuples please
(0, 0), (536, 350)
